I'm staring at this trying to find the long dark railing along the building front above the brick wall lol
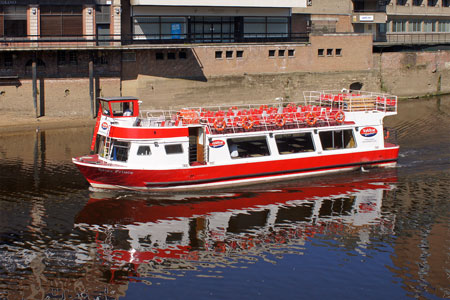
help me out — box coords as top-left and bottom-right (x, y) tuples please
(0, 32), (309, 48)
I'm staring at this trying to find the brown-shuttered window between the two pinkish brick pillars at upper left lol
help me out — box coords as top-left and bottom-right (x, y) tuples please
(41, 5), (83, 38)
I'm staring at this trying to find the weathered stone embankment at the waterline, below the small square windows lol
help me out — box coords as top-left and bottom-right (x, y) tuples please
(0, 51), (450, 133)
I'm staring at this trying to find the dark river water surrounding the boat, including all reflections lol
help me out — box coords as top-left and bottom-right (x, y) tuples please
(0, 96), (450, 300)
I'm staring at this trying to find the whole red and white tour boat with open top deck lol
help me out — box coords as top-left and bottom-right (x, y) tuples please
(73, 90), (399, 191)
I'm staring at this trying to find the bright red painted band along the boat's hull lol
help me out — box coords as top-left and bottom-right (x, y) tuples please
(77, 147), (399, 188)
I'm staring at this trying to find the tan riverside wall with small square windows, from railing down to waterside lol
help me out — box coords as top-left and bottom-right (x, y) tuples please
(0, 42), (450, 117)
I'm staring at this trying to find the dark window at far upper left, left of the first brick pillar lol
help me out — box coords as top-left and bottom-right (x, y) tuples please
(0, 5), (27, 37)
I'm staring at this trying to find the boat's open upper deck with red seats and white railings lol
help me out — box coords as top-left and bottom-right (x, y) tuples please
(135, 91), (397, 134)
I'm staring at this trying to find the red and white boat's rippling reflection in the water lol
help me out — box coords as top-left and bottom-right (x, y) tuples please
(76, 171), (396, 282)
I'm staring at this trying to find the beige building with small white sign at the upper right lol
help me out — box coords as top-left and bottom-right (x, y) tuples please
(293, 0), (450, 46)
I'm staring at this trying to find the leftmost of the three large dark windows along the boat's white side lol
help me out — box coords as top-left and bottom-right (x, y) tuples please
(227, 136), (270, 159)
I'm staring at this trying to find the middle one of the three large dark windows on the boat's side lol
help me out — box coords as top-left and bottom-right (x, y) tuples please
(275, 132), (315, 155)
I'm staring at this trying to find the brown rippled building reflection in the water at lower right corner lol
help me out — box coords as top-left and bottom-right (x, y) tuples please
(389, 176), (450, 299)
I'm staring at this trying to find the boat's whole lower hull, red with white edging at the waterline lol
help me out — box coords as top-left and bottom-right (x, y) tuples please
(74, 147), (399, 190)
